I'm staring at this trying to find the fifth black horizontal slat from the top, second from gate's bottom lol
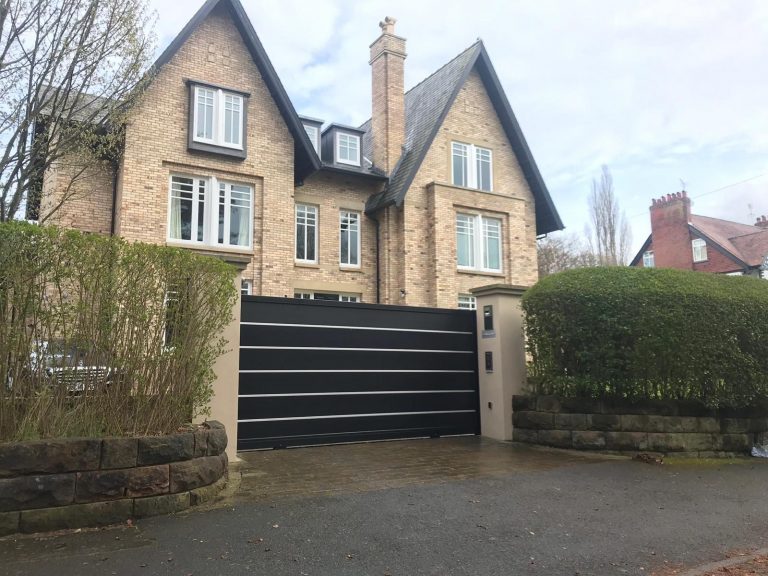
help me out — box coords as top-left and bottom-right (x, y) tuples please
(239, 391), (477, 420)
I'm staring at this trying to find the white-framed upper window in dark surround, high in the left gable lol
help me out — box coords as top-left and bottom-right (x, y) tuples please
(192, 86), (245, 150)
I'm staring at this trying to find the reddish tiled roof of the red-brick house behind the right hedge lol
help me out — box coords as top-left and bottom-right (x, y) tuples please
(629, 214), (768, 268)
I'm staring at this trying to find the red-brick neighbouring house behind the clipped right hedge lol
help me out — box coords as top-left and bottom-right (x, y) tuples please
(630, 191), (768, 277)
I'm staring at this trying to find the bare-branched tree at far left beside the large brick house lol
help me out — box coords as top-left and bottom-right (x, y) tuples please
(0, 0), (154, 221)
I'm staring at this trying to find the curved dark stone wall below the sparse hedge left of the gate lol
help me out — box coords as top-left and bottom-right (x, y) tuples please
(0, 422), (227, 536)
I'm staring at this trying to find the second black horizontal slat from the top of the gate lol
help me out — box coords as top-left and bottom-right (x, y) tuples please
(240, 324), (475, 350)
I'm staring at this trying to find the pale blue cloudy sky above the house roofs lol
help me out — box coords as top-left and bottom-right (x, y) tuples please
(150, 0), (768, 254)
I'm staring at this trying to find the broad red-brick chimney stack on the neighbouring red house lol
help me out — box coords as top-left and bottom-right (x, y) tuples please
(650, 190), (693, 270)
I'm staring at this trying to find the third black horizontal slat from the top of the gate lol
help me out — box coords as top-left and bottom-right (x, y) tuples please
(240, 349), (476, 371)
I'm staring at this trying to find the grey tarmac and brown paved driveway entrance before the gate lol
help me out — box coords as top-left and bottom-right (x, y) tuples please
(0, 437), (768, 576)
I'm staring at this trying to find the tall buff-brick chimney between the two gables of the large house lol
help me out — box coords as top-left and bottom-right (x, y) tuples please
(370, 16), (406, 174)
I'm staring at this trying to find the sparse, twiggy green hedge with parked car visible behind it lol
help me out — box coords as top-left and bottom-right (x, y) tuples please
(0, 222), (237, 442)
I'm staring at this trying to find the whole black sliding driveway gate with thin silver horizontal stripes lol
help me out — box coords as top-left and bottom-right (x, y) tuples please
(237, 296), (480, 450)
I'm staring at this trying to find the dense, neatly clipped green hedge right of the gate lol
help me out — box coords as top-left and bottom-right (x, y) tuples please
(523, 267), (768, 406)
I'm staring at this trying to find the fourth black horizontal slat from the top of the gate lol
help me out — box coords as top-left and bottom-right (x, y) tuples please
(239, 372), (477, 394)
